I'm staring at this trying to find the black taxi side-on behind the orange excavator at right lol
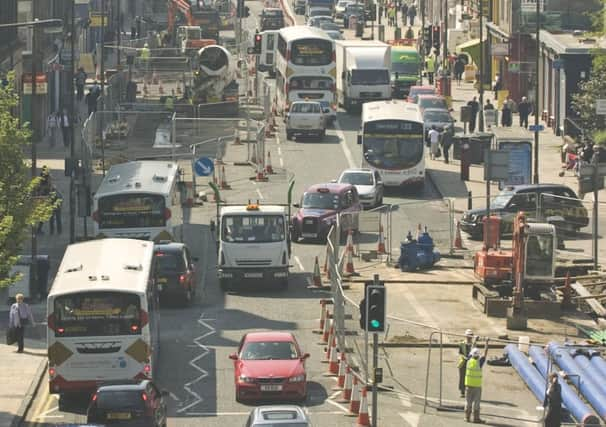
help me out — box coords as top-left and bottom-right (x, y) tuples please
(460, 184), (589, 239)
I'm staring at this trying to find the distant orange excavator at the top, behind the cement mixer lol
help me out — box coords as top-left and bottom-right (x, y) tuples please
(167, 0), (221, 47)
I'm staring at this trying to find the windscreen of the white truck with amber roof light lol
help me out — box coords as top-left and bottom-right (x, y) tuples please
(221, 215), (286, 243)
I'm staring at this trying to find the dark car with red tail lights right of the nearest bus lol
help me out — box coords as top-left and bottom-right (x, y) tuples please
(154, 242), (198, 305)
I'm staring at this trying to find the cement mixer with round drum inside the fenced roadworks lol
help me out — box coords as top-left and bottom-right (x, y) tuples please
(192, 45), (239, 116)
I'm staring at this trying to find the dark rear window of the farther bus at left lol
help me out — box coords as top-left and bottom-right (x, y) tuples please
(97, 193), (166, 229)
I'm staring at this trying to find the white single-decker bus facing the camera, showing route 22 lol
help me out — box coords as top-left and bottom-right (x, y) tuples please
(358, 99), (425, 188)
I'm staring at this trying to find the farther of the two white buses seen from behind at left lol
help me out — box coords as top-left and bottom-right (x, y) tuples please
(93, 160), (184, 241)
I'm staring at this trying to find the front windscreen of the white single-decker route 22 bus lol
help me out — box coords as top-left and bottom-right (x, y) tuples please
(363, 120), (423, 170)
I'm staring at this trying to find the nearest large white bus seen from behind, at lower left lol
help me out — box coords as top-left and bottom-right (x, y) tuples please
(47, 239), (159, 398)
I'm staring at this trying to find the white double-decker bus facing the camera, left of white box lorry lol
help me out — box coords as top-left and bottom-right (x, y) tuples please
(275, 25), (337, 120)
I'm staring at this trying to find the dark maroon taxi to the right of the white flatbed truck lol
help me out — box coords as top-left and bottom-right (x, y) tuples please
(291, 183), (362, 242)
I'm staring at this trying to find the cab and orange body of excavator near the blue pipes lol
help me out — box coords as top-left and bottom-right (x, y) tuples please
(474, 212), (557, 299)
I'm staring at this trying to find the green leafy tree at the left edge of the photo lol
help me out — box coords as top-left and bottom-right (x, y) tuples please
(0, 76), (54, 287)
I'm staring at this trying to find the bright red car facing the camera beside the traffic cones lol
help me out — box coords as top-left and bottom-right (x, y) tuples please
(229, 332), (309, 402)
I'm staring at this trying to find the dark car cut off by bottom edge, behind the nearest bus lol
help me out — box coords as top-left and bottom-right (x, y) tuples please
(86, 380), (168, 427)
